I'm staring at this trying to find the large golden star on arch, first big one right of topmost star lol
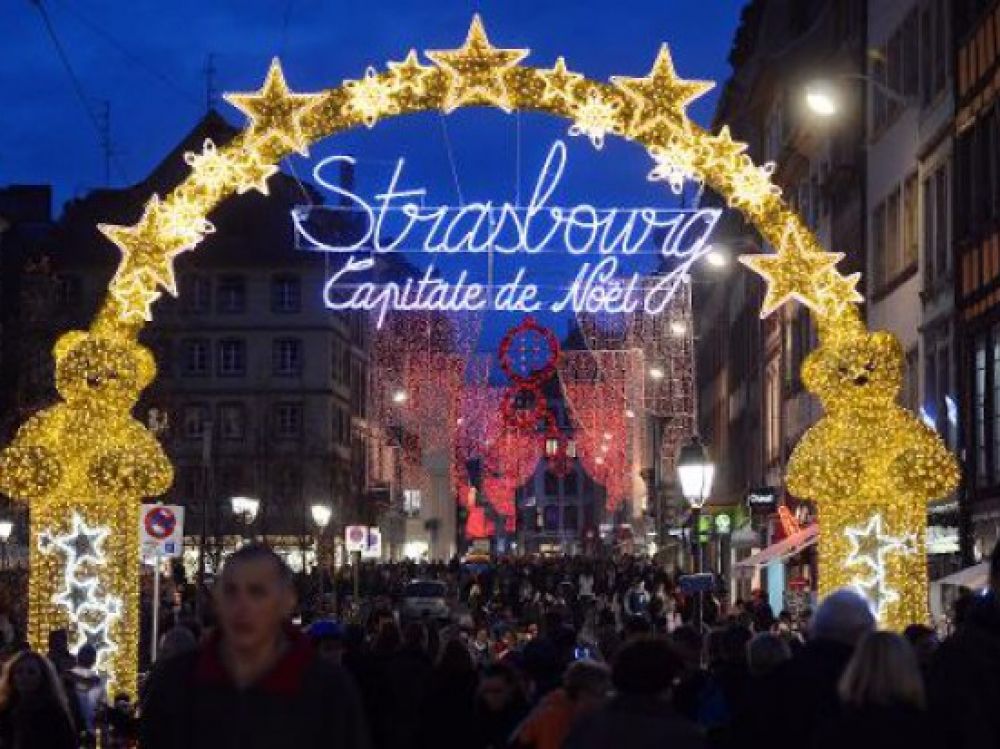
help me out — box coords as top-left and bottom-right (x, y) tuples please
(611, 44), (715, 139)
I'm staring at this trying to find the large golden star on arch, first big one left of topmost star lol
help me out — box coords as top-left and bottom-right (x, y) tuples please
(223, 57), (326, 156)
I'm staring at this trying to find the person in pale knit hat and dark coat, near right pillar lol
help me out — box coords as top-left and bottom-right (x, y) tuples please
(734, 588), (875, 749)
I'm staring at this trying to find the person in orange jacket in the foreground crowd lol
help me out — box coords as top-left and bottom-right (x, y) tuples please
(511, 660), (611, 749)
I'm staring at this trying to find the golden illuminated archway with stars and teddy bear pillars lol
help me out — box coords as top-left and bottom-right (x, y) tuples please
(0, 16), (958, 692)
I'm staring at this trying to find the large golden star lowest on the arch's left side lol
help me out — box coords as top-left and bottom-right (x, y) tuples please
(97, 195), (201, 296)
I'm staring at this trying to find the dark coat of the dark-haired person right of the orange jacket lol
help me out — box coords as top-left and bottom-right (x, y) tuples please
(564, 695), (707, 749)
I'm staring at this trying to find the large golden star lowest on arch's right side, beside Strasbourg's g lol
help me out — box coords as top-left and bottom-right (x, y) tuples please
(740, 222), (844, 319)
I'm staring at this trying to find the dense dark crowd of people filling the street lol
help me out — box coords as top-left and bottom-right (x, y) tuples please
(0, 544), (1000, 749)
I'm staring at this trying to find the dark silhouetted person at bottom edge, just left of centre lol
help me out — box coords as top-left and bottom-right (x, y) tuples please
(416, 639), (477, 749)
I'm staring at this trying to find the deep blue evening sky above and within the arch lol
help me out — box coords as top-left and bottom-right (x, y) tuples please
(0, 0), (744, 338)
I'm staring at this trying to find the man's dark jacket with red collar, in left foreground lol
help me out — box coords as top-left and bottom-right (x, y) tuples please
(140, 630), (369, 749)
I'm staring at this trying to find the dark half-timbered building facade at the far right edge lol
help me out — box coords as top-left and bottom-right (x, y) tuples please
(952, 0), (1000, 562)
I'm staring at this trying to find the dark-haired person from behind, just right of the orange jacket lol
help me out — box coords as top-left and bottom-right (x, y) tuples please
(564, 635), (707, 749)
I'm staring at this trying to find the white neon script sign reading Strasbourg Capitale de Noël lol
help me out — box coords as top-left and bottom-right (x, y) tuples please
(292, 141), (722, 327)
